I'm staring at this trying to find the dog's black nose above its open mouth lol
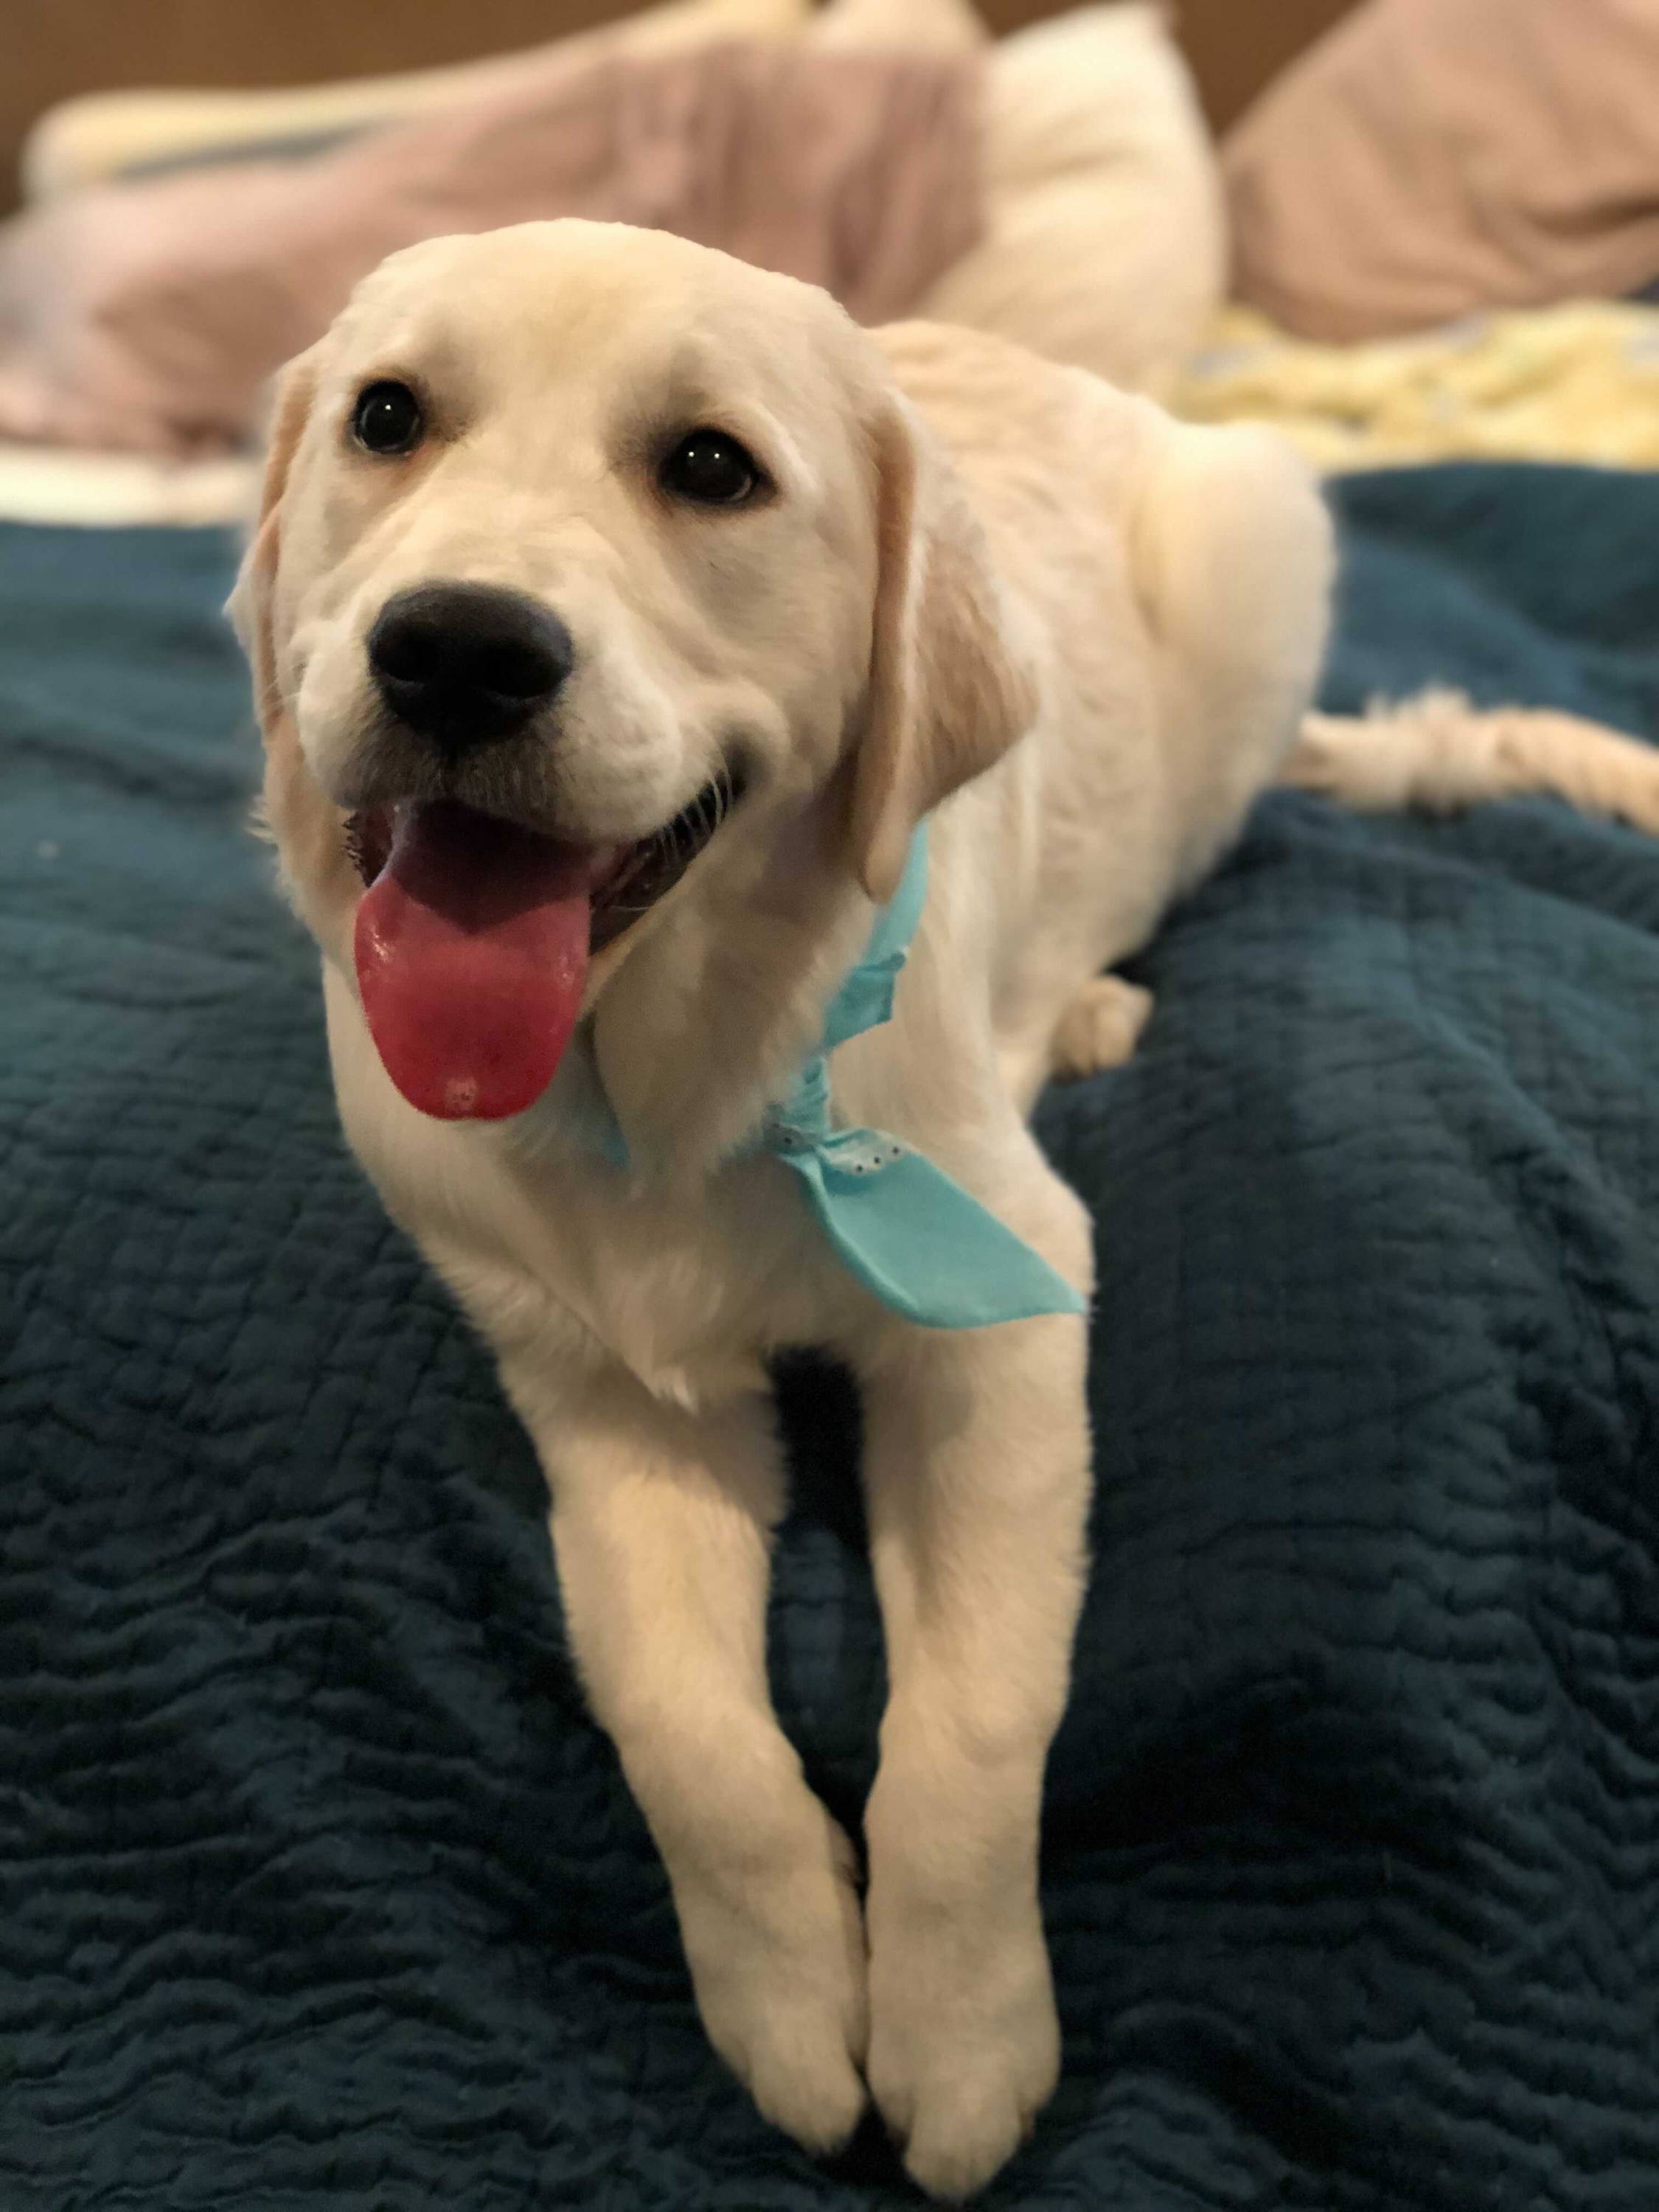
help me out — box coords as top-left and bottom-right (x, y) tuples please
(369, 584), (575, 752)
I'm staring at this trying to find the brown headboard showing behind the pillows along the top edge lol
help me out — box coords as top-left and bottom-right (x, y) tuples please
(0, 0), (1354, 208)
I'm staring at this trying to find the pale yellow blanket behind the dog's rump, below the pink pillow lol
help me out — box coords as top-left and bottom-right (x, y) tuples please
(1170, 301), (1659, 471)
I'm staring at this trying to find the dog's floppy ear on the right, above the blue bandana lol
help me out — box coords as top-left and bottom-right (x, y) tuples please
(849, 398), (1037, 905)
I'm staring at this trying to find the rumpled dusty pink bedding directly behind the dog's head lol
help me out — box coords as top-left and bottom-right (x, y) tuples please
(0, 44), (980, 453)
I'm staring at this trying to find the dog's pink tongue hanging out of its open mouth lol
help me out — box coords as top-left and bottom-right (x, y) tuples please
(354, 805), (608, 1121)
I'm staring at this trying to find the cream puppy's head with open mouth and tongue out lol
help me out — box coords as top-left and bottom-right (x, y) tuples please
(232, 221), (1031, 1117)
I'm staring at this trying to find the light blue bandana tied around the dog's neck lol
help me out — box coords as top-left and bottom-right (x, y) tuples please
(604, 825), (1084, 1329)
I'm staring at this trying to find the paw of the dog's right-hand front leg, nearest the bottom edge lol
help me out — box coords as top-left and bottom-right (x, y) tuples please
(869, 1907), (1060, 2203)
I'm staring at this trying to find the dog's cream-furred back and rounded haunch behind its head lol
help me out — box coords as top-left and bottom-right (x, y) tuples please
(878, 323), (1332, 1095)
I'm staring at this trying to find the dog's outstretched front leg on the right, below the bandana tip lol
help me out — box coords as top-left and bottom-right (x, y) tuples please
(863, 1318), (1088, 2197)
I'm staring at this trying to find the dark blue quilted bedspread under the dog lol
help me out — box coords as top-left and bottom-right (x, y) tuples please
(0, 467), (1659, 2212)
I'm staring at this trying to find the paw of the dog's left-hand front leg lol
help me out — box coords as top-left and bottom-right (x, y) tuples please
(675, 1814), (869, 2154)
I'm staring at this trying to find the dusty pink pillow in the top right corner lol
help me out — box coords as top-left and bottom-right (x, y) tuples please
(1223, 0), (1659, 341)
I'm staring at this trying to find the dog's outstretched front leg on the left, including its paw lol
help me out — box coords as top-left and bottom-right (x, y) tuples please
(504, 1363), (867, 2150)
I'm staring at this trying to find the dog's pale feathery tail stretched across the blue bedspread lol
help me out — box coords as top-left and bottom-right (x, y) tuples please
(1279, 690), (1659, 836)
